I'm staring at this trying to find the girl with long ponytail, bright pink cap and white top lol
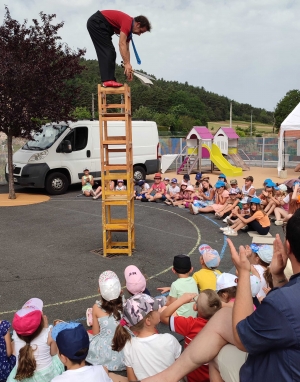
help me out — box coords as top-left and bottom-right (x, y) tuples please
(7, 298), (64, 382)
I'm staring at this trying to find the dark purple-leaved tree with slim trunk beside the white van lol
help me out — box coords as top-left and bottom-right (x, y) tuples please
(0, 7), (85, 198)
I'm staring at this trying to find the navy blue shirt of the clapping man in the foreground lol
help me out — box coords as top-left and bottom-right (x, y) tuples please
(237, 273), (300, 382)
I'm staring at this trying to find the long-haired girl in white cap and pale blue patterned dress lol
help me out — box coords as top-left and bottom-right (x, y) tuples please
(86, 271), (125, 371)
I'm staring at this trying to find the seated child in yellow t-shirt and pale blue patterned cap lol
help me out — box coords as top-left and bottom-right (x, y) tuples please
(193, 244), (221, 292)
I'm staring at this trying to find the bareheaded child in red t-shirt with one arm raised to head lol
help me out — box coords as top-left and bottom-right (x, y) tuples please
(160, 289), (222, 382)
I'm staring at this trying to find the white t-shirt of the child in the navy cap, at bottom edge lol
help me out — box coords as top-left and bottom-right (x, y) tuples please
(51, 365), (112, 382)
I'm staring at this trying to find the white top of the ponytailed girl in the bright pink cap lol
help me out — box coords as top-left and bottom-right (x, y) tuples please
(12, 328), (52, 370)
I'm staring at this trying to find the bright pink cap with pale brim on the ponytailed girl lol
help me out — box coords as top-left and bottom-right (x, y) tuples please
(12, 298), (43, 336)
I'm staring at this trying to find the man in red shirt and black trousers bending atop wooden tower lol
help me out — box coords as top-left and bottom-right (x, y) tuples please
(87, 11), (151, 87)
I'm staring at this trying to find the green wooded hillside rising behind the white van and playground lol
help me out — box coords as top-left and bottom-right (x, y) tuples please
(74, 59), (273, 132)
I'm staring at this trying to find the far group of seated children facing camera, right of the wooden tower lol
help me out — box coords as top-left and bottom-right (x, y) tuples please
(135, 173), (300, 236)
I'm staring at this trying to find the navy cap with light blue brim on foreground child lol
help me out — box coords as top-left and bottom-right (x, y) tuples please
(51, 322), (90, 360)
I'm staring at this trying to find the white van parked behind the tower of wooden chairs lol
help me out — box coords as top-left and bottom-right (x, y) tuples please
(5, 121), (160, 195)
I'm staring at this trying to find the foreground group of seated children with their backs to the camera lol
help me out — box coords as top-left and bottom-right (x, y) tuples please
(0, 239), (280, 382)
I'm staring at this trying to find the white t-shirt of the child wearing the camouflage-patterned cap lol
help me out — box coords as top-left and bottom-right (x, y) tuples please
(124, 333), (181, 380)
